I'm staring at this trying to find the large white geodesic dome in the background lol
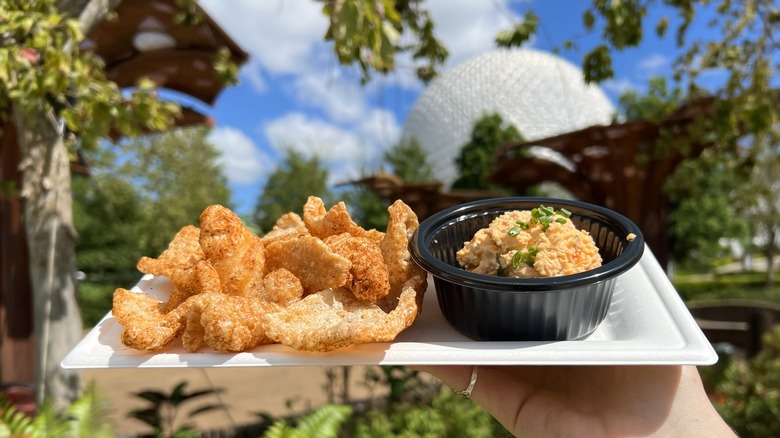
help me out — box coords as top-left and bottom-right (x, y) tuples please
(402, 49), (615, 184)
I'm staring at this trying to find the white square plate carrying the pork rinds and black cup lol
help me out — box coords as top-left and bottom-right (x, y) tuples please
(62, 248), (718, 368)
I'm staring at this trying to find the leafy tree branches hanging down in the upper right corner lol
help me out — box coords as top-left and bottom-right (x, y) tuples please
(496, 0), (780, 163)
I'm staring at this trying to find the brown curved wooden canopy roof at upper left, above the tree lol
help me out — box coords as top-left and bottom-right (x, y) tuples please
(81, 0), (249, 125)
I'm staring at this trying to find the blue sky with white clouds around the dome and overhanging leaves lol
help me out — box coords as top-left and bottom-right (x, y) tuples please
(200, 0), (720, 214)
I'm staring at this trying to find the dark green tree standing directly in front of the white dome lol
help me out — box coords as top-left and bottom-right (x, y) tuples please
(452, 113), (523, 189)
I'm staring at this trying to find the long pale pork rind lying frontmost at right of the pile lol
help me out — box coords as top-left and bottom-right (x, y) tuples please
(263, 283), (422, 351)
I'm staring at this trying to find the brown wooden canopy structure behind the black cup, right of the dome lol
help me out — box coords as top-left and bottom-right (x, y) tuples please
(490, 97), (714, 266)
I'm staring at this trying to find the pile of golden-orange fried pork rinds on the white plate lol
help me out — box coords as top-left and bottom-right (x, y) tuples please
(113, 196), (427, 352)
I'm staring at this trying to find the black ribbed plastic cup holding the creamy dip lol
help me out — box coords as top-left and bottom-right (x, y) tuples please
(410, 197), (645, 341)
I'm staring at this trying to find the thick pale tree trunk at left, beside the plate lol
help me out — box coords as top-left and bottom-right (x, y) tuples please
(14, 110), (81, 408)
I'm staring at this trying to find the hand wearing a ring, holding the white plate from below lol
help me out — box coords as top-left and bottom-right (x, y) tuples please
(413, 366), (735, 438)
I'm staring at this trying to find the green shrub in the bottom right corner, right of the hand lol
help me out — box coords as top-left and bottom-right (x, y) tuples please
(712, 325), (780, 438)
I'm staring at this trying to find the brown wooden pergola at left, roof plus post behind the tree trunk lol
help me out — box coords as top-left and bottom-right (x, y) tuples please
(0, 0), (248, 383)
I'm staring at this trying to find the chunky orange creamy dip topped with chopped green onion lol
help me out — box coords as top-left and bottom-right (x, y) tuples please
(457, 206), (601, 278)
